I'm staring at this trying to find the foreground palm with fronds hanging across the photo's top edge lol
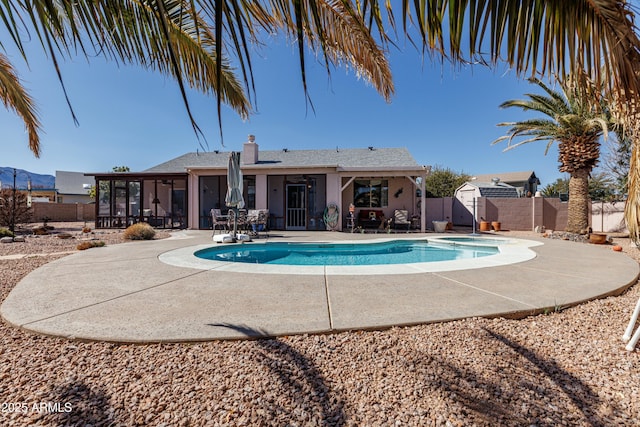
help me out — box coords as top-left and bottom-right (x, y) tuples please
(0, 0), (640, 240)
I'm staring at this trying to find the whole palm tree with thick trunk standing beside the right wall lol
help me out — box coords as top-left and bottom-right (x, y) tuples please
(493, 79), (612, 234)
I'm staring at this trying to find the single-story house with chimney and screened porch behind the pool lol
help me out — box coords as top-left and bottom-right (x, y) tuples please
(88, 137), (427, 230)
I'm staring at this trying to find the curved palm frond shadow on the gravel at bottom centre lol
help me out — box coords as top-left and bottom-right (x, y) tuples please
(210, 323), (345, 426)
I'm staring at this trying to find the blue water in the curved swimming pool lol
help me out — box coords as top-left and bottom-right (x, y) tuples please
(195, 240), (499, 265)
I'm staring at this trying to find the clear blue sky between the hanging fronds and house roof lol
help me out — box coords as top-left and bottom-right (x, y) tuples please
(0, 28), (584, 185)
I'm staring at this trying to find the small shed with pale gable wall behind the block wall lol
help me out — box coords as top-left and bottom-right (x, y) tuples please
(452, 178), (520, 226)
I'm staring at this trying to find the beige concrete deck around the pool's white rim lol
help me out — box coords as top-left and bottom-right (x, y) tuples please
(0, 231), (639, 343)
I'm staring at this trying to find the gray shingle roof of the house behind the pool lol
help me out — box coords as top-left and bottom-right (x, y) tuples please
(144, 148), (420, 173)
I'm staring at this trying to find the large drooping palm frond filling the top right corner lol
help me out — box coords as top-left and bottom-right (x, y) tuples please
(365, 0), (640, 113)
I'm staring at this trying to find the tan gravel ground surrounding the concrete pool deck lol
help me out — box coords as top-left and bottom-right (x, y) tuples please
(0, 226), (640, 426)
